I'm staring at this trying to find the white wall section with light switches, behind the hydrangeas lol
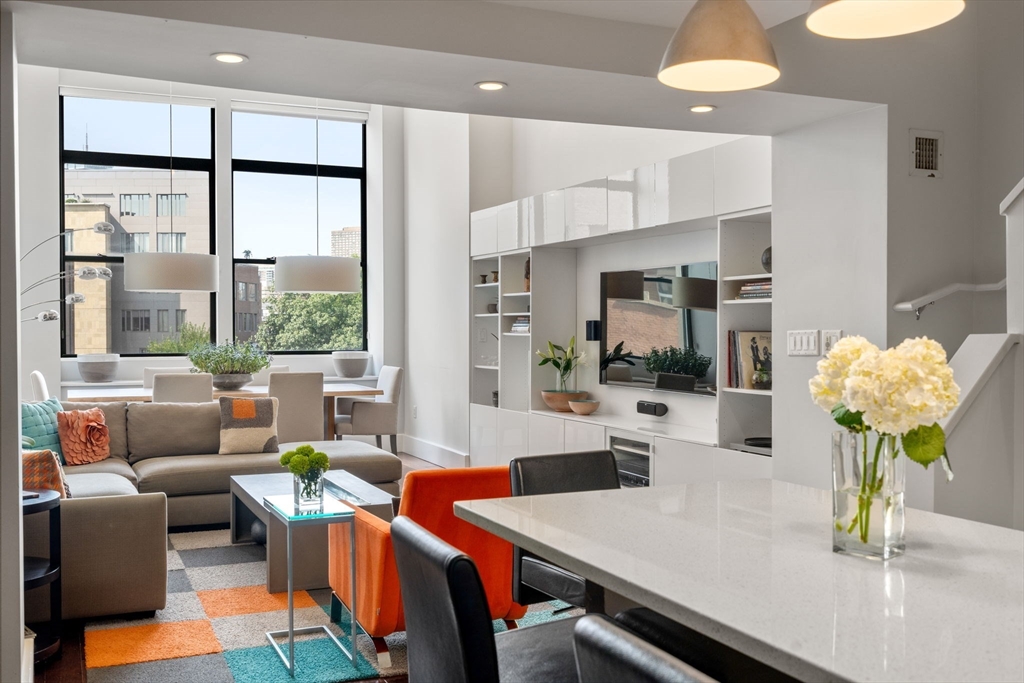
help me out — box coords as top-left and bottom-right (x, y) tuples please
(772, 106), (884, 489)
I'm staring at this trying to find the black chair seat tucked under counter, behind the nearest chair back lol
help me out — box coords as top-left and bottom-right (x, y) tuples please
(615, 607), (797, 683)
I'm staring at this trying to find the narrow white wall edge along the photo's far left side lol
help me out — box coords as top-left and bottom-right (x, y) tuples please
(0, 8), (25, 681)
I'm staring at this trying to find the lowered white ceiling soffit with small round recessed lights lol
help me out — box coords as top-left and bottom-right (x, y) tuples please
(7, 0), (865, 135)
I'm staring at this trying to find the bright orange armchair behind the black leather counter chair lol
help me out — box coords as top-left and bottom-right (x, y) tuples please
(328, 467), (526, 668)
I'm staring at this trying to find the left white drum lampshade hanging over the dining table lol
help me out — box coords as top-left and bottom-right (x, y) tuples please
(125, 252), (219, 292)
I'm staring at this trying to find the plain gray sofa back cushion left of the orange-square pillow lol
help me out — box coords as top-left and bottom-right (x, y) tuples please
(128, 402), (220, 464)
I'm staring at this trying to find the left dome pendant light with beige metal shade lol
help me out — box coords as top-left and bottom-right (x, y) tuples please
(657, 0), (781, 92)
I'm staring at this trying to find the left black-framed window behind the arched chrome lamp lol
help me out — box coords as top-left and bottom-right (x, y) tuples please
(60, 95), (216, 356)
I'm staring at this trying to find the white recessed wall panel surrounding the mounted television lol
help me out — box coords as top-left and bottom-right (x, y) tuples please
(577, 230), (718, 432)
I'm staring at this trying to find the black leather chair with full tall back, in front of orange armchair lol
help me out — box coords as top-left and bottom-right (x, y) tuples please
(391, 516), (578, 683)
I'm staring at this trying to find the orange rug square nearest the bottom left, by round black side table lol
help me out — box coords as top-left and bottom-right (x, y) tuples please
(85, 620), (221, 669)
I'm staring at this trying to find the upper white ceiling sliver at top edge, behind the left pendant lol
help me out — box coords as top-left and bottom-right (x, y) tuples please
(487, 0), (811, 29)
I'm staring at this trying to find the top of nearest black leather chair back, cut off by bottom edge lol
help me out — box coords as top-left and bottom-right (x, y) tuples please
(574, 614), (715, 683)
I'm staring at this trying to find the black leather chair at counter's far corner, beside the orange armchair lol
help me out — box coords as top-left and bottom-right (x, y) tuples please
(509, 451), (618, 611)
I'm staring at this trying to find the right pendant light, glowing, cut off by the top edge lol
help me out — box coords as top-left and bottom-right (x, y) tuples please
(807, 0), (966, 40)
